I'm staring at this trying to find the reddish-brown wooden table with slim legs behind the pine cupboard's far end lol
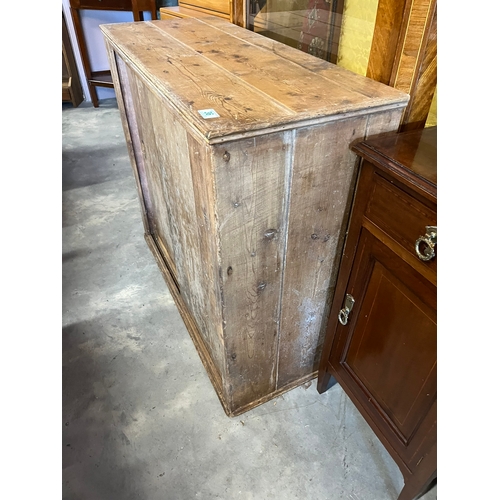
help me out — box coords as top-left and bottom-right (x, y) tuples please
(70, 0), (157, 108)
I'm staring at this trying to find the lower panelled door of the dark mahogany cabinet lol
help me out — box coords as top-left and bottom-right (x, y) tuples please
(330, 225), (437, 465)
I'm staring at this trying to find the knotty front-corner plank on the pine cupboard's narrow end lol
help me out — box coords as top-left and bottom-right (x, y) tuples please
(214, 132), (292, 411)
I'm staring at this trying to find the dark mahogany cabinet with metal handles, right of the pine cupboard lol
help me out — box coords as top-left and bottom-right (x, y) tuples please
(318, 127), (437, 500)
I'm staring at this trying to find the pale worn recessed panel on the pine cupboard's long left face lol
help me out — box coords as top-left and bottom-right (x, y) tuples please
(117, 62), (223, 376)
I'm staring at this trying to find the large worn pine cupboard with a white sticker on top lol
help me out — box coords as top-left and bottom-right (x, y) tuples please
(101, 16), (408, 416)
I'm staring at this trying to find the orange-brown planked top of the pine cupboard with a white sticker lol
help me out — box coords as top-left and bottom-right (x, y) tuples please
(101, 16), (409, 144)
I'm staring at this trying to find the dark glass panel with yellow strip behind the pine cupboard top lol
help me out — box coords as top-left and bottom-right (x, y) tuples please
(248, 0), (378, 75)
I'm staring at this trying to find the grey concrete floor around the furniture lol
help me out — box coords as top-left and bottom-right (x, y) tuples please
(62, 99), (437, 500)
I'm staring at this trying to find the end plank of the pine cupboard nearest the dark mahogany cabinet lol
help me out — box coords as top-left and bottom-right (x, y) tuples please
(276, 109), (403, 389)
